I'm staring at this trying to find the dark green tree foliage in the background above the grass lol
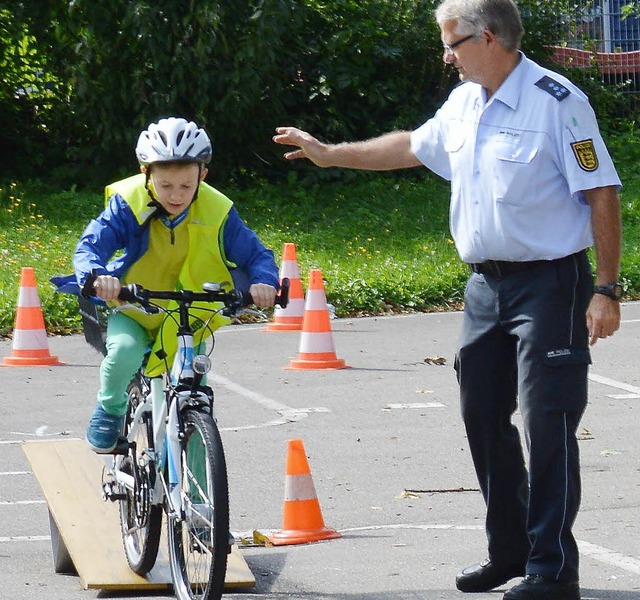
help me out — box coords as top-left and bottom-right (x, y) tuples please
(0, 0), (624, 183)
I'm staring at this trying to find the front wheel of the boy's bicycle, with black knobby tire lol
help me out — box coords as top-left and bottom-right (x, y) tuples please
(167, 408), (229, 600)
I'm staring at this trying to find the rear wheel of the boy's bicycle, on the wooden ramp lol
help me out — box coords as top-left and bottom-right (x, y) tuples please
(119, 373), (162, 575)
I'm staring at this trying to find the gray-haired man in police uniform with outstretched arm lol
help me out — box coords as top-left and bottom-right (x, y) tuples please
(274, 0), (622, 600)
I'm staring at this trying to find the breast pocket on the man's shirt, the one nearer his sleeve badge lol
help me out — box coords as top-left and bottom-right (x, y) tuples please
(494, 142), (540, 205)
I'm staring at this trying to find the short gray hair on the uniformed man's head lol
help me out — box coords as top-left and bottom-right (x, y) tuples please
(436, 0), (524, 50)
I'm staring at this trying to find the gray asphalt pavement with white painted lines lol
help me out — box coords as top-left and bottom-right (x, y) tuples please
(0, 303), (640, 600)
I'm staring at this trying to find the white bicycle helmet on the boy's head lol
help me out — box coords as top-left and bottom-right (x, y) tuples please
(136, 117), (213, 166)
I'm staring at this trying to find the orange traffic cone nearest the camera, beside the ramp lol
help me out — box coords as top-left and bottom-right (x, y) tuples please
(269, 440), (342, 546)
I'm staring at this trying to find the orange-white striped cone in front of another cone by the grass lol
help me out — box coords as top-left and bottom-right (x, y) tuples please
(288, 269), (347, 369)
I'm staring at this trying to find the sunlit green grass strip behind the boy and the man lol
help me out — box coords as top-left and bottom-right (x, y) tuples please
(0, 132), (640, 335)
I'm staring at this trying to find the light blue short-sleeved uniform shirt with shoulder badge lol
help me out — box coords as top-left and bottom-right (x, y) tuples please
(411, 54), (620, 263)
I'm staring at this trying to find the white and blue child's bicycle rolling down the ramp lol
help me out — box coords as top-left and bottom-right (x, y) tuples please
(81, 278), (289, 600)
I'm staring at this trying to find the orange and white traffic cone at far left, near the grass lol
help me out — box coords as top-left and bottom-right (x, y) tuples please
(2, 267), (64, 367)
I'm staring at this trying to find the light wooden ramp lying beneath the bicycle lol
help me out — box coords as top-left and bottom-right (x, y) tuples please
(22, 440), (255, 590)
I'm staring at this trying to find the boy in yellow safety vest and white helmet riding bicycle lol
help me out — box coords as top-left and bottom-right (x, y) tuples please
(56, 117), (279, 454)
